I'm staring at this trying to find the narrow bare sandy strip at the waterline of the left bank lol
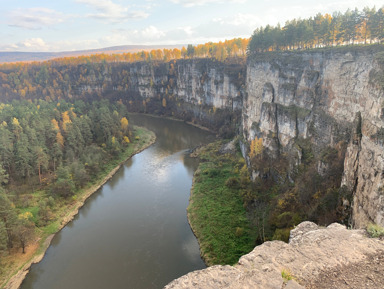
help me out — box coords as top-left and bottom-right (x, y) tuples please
(2, 127), (156, 289)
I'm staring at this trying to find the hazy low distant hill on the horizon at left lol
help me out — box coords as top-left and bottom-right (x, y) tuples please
(0, 44), (186, 63)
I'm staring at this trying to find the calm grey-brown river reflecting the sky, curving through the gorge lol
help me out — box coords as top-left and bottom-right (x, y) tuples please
(21, 115), (213, 289)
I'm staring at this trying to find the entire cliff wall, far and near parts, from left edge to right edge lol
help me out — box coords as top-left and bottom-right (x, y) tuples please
(0, 46), (384, 227)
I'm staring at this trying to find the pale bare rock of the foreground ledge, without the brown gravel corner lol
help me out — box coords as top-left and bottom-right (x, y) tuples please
(165, 222), (384, 289)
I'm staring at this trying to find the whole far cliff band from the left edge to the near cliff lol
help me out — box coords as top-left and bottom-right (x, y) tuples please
(0, 59), (245, 134)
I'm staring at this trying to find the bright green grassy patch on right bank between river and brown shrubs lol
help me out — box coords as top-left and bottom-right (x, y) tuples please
(188, 142), (255, 265)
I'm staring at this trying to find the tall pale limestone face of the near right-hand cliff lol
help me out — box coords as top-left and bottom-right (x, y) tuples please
(243, 48), (384, 227)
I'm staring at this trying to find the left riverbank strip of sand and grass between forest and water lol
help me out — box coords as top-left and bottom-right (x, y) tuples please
(0, 127), (156, 289)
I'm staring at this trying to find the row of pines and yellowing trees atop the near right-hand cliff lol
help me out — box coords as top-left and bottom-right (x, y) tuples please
(247, 7), (384, 55)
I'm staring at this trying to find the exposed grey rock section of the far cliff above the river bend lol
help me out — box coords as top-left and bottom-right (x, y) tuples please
(104, 59), (245, 133)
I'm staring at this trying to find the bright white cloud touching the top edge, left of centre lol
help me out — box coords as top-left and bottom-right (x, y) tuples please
(76, 0), (149, 23)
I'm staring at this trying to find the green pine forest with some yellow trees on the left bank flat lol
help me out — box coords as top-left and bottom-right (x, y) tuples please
(0, 100), (139, 261)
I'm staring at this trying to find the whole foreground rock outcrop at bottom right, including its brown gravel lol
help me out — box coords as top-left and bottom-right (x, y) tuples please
(164, 222), (384, 289)
